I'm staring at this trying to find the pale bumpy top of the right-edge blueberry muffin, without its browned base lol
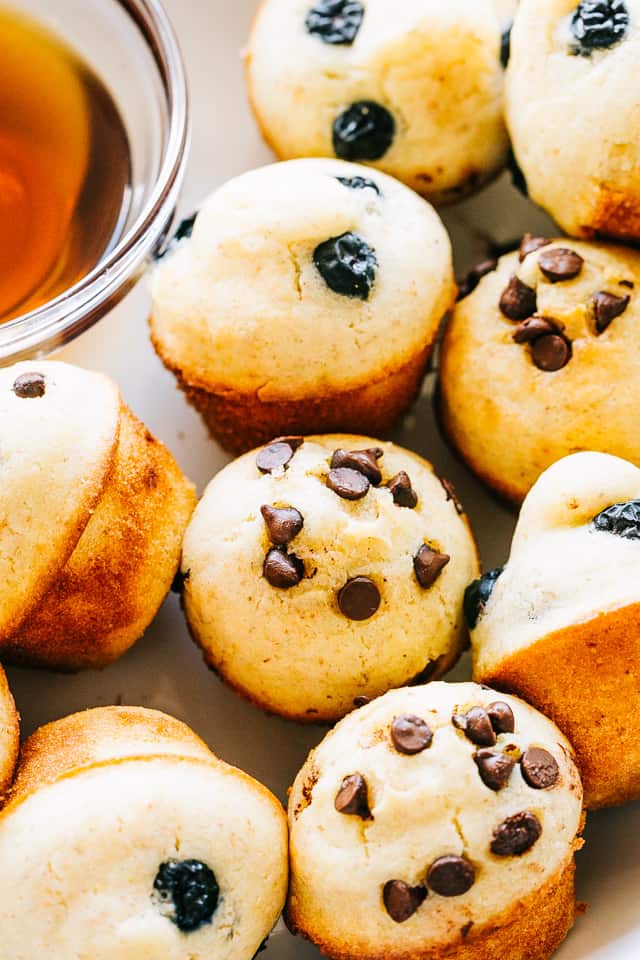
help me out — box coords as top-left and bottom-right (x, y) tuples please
(466, 453), (640, 674)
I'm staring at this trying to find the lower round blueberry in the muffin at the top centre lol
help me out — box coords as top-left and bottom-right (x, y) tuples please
(333, 100), (396, 160)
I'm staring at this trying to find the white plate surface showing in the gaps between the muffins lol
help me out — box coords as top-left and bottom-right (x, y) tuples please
(11, 0), (640, 960)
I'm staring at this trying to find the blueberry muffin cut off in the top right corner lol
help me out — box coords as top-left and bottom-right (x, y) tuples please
(506, 0), (640, 239)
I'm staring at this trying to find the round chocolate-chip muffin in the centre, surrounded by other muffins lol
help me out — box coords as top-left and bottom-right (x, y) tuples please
(182, 435), (477, 721)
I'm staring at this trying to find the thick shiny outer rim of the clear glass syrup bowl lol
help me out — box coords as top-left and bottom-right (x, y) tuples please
(0, 0), (189, 365)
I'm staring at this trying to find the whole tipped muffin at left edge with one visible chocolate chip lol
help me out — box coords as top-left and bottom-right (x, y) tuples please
(0, 360), (195, 670)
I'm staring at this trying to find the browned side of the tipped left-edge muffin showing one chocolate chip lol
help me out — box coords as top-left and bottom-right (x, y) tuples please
(0, 404), (195, 671)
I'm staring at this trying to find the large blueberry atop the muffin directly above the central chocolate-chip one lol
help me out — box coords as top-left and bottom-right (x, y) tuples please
(313, 233), (378, 300)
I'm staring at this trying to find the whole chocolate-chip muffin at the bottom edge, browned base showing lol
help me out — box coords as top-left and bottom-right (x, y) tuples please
(286, 683), (582, 960)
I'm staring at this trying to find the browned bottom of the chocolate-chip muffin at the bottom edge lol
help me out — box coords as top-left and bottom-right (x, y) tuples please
(285, 860), (579, 960)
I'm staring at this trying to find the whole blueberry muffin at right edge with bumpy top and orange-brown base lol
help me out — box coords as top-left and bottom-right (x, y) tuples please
(465, 453), (640, 808)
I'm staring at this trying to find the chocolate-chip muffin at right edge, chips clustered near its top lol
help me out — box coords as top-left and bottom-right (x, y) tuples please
(439, 235), (640, 502)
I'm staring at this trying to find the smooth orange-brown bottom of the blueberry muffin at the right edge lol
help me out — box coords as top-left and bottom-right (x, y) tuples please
(474, 603), (640, 810)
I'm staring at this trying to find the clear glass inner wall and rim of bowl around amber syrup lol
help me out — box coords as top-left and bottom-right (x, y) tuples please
(0, 0), (189, 366)
